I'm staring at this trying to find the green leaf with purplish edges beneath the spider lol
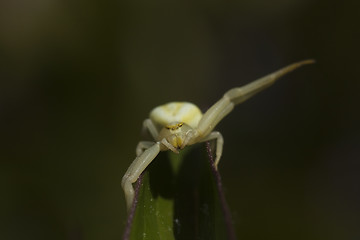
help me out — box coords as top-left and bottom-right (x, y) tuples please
(125, 145), (233, 240)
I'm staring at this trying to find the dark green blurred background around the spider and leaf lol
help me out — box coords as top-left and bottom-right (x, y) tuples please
(0, 0), (360, 240)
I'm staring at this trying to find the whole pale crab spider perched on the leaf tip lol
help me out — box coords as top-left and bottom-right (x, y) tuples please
(121, 60), (314, 210)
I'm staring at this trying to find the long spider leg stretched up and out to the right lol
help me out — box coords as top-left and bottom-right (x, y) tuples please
(194, 60), (314, 137)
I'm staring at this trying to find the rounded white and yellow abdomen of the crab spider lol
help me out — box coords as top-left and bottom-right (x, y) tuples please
(150, 102), (202, 128)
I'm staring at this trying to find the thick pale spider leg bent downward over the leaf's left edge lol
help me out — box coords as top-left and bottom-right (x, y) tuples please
(121, 142), (160, 210)
